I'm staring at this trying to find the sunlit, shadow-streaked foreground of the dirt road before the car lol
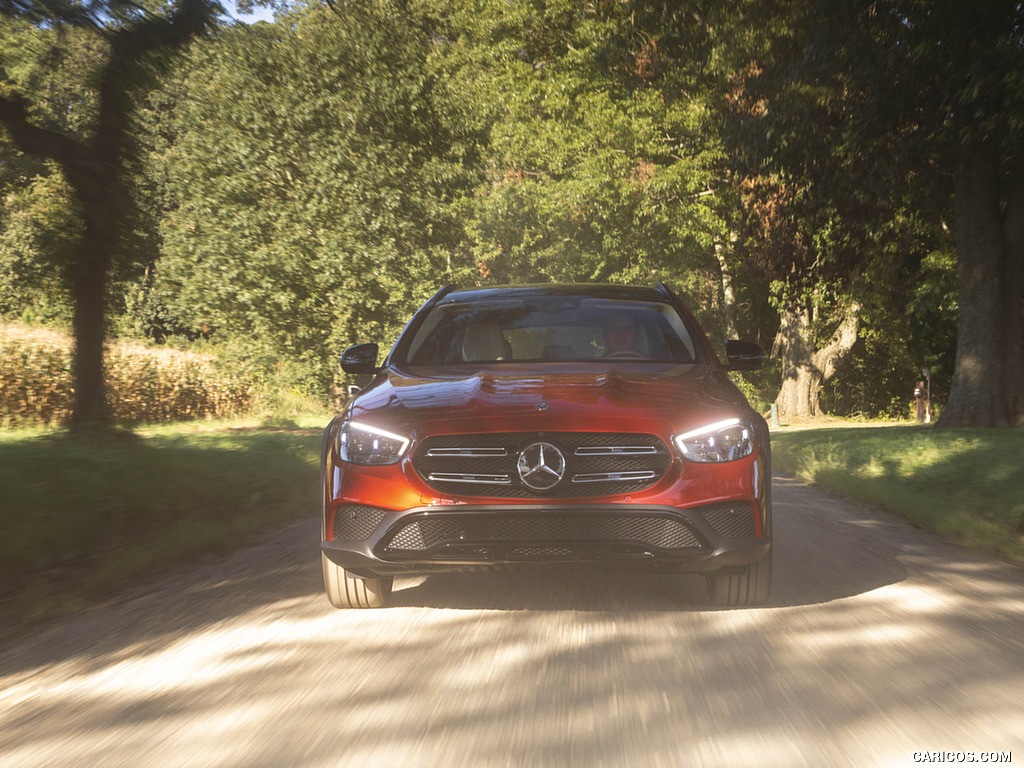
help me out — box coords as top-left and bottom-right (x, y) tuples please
(0, 565), (1024, 768)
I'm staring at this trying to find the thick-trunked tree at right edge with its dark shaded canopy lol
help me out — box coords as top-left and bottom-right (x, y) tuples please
(737, 0), (1024, 426)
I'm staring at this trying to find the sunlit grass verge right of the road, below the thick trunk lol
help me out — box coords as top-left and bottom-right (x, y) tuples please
(772, 426), (1024, 564)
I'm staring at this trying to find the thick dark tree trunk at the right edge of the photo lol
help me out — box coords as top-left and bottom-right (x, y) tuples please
(938, 144), (1024, 427)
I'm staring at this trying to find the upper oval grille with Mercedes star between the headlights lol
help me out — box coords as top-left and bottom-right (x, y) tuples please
(413, 432), (672, 499)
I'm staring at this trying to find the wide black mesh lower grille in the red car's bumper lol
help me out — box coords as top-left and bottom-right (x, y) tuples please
(381, 511), (701, 560)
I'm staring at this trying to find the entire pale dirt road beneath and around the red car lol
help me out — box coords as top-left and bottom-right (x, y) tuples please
(0, 478), (1024, 768)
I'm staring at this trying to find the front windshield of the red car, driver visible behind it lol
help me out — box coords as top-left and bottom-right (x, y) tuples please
(399, 294), (698, 366)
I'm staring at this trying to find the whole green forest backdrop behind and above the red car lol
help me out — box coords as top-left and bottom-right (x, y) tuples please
(0, 0), (1024, 434)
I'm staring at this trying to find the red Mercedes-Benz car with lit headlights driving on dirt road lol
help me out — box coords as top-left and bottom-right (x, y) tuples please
(322, 285), (772, 608)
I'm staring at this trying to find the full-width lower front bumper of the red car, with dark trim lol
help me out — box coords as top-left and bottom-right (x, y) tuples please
(322, 500), (771, 578)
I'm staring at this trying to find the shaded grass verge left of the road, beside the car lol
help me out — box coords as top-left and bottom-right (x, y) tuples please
(0, 417), (328, 626)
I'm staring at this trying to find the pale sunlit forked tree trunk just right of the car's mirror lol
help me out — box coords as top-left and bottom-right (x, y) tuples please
(772, 302), (860, 419)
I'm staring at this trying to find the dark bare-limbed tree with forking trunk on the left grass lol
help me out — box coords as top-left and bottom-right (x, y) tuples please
(0, 0), (219, 431)
